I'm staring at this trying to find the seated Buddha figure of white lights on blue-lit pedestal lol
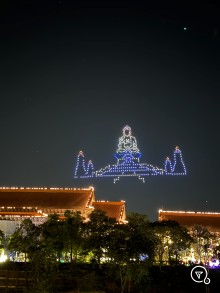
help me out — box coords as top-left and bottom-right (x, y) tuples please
(115, 125), (141, 164)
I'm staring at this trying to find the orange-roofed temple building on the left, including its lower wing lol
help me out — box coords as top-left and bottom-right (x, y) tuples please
(0, 187), (126, 235)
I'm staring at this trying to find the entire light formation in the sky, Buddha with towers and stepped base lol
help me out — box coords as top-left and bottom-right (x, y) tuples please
(74, 125), (186, 183)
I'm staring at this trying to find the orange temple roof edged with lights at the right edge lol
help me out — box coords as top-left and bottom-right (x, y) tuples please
(158, 210), (220, 232)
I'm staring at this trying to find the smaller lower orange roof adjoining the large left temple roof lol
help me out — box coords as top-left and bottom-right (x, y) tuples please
(93, 201), (126, 222)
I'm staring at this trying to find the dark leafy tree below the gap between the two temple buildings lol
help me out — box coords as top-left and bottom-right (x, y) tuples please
(108, 213), (155, 293)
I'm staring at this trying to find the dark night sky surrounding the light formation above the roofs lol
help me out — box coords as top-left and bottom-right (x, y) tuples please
(0, 0), (220, 220)
